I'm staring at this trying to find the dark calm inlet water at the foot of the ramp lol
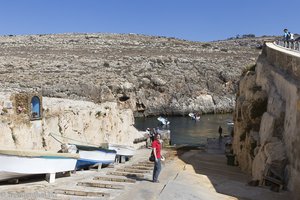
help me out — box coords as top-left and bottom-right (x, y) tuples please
(135, 114), (232, 145)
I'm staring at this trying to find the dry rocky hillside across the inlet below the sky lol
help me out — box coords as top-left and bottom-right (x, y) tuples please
(0, 34), (266, 116)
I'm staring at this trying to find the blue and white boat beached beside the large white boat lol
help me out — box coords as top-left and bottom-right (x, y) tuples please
(68, 144), (117, 169)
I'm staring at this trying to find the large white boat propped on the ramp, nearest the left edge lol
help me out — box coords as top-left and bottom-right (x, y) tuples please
(0, 150), (79, 183)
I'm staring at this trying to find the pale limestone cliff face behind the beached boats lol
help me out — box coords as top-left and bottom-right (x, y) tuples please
(0, 94), (142, 151)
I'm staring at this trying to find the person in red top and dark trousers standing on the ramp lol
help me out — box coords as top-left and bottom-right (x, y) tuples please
(152, 134), (161, 183)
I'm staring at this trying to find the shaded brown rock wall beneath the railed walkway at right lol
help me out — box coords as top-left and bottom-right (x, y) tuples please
(233, 43), (300, 191)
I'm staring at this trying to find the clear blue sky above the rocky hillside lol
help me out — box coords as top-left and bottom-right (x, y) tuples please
(0, 0), (300, 41)
